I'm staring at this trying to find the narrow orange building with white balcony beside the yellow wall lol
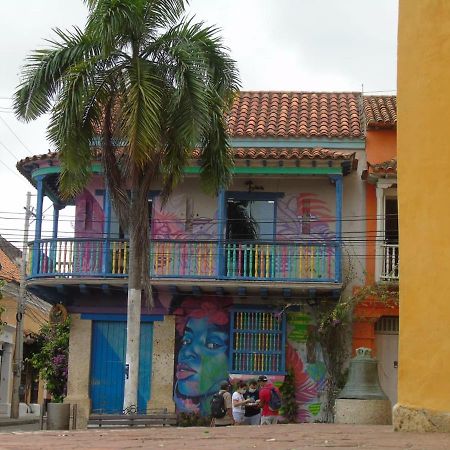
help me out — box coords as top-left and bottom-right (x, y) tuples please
(353, 96), (399, 405)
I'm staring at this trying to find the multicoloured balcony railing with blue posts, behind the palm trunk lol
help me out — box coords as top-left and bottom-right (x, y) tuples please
(27, 238), (340, 283)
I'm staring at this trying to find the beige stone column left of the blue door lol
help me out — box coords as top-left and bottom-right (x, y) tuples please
(64, 314), (92, 429)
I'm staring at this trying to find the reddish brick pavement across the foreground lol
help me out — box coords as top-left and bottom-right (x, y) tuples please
(0, 424), (450, 450)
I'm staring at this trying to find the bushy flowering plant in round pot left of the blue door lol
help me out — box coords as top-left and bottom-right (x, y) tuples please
(29, 318), (70, 430)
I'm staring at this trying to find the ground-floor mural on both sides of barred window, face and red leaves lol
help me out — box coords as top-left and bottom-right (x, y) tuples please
(169, 296), (325, 422)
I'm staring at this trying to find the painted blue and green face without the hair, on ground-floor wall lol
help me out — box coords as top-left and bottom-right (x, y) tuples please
(176, 317), (228, 397)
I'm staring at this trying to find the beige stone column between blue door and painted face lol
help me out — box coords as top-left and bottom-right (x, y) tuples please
(147, 316), (175, 412)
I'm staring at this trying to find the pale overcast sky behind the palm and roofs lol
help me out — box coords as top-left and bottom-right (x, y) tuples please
(0, 0), (398, 250)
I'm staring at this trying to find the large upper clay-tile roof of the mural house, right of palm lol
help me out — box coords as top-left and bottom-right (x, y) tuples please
(228, 92), (363, 138)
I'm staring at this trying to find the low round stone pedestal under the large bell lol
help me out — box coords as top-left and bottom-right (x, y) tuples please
(334, 398), (392, 425)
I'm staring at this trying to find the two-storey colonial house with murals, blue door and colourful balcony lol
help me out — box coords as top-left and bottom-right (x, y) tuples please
(18, 92), (367, 426)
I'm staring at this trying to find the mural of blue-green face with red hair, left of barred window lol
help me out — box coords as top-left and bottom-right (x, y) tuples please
(173, 296), (231, 415)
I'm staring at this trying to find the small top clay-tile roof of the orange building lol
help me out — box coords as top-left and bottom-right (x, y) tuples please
(363, 95), (397, 128)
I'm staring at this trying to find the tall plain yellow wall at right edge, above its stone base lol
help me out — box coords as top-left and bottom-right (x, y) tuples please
(394, 0), (450, 414)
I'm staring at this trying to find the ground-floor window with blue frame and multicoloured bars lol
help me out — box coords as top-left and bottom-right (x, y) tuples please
(230, 309), (286, 375)
